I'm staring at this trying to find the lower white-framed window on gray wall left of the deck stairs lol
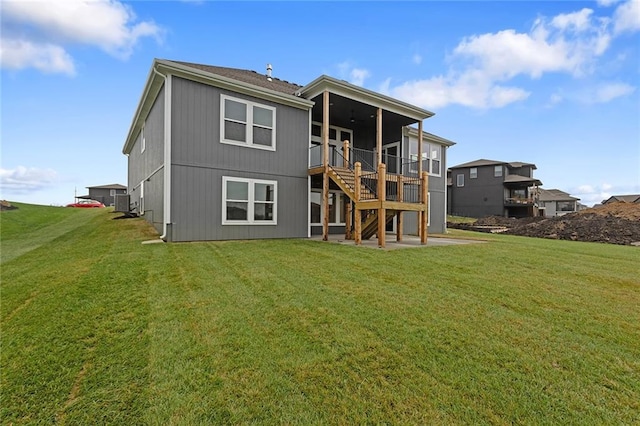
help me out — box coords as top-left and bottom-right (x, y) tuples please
(222, 176), (278, 225)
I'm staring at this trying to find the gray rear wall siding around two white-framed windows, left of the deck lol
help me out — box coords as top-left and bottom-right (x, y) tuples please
(171, 78), (309, 241)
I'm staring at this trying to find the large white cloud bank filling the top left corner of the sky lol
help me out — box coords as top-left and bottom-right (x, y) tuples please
(0, 0), (162, 74)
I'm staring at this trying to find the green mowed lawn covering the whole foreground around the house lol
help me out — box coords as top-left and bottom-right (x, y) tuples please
(0, 204), (640, 425)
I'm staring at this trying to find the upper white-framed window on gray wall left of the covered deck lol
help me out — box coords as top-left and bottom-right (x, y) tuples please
(220, 95), (276, 151)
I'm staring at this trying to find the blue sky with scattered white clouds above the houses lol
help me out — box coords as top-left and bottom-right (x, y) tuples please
(0, 0), (640, 205)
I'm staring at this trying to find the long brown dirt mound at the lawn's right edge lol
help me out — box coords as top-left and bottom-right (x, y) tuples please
(505, 202), (640, 245)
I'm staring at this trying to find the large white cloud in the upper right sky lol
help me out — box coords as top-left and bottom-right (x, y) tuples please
(385, 0), (640, 109)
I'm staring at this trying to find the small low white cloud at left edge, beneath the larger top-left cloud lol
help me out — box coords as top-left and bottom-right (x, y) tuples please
(0, 39), (75, 75)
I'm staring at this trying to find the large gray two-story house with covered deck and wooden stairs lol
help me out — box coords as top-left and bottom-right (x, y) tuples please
(123, 59), (454, 246)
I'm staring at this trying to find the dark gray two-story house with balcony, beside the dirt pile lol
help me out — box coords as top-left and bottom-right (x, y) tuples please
(447, 159), (542, 218)
